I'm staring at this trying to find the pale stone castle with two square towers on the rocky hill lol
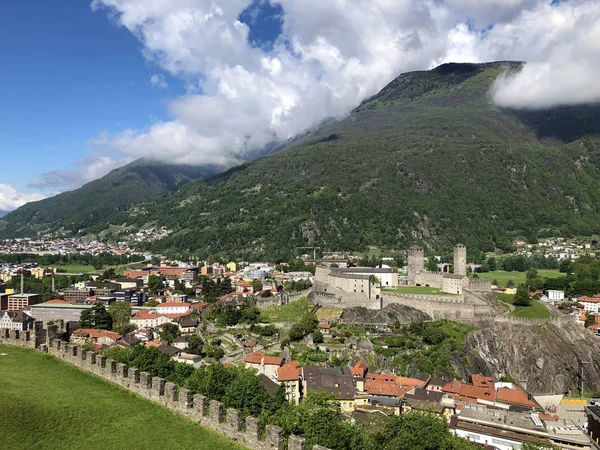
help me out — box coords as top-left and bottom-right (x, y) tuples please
(313, 244), (493, 320)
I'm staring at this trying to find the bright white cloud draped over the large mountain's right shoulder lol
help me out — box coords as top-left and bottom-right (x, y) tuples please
(492, 2), (600, 108)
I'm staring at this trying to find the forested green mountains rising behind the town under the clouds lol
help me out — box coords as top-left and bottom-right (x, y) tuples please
(0, 62), (600, 258)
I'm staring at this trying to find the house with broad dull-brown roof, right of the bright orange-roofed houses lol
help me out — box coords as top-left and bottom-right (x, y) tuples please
(302, 366), (356, 412)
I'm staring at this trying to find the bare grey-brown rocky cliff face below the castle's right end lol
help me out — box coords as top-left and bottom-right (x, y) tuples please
(456, 321), (600, 394)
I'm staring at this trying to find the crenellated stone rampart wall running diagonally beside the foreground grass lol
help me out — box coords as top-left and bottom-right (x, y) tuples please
(0, 329), (327, 450)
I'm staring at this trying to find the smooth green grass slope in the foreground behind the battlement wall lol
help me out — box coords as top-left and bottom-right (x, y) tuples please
(0, 345), (243, 450)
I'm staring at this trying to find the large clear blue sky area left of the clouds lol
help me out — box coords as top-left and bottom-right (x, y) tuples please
(0, 0), (184, 189)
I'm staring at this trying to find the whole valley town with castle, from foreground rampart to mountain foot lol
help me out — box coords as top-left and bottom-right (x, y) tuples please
(0, 237), (600, 450)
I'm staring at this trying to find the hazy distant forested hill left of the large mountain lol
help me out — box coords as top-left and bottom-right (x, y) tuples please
(0, 159), (216, 238)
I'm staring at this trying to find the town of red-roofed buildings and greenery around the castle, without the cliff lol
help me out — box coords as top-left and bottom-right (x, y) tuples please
(0, 240), (600, 450)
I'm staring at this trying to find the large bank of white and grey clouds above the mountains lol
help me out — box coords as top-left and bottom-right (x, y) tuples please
(79, 0), (600, 169)
